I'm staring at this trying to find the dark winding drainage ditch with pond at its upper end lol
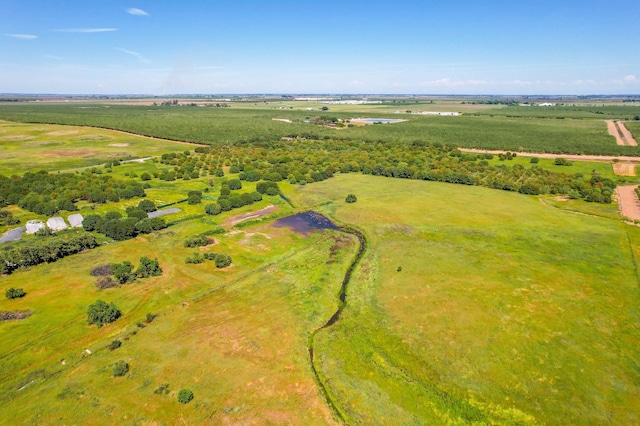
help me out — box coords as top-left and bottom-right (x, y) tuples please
(274, 211), (367, 421)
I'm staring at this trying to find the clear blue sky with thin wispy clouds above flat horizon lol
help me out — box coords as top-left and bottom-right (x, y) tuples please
(0, 0), (640, 95)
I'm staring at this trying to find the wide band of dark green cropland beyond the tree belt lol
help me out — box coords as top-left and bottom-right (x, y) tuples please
(0, 104), (640, 156)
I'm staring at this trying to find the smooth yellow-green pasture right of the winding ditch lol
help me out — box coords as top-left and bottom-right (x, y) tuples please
(295, 175), (640, 424)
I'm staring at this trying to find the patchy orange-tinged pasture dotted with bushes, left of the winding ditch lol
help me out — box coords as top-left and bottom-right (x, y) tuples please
(0, 203), (355, 424)
